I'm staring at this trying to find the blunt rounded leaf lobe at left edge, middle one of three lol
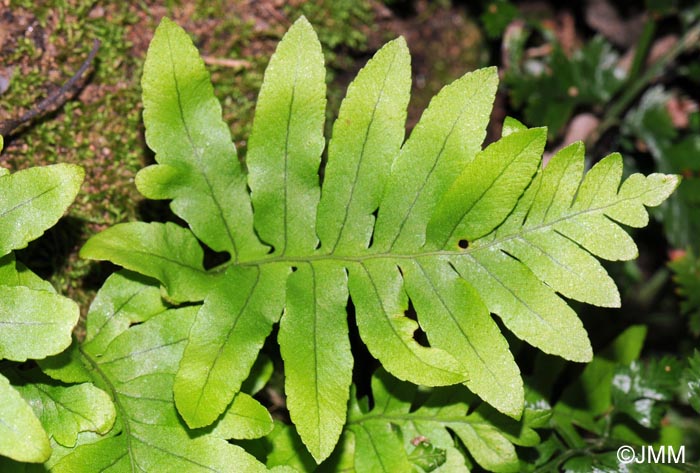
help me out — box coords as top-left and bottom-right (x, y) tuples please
(0, 286), (80, 361)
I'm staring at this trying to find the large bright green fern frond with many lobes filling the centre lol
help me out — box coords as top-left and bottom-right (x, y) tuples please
(82, 18), (678, 462)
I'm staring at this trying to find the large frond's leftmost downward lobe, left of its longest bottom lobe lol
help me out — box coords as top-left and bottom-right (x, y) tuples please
(174, 265), (288, 428)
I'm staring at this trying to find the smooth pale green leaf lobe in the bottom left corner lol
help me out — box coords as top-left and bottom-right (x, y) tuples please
(0, 374), (51, 463)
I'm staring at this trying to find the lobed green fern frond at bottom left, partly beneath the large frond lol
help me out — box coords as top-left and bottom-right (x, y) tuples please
(52, 273), (288, 472)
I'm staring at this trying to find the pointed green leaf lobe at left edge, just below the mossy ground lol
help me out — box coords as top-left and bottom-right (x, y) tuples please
(0, 164), (85, 256)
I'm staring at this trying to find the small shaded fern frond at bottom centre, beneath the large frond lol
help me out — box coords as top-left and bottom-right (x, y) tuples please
(347, 369), (540, 472)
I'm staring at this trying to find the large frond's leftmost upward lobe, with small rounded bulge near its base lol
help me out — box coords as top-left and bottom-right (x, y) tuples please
(136, 18), (266, 259)
